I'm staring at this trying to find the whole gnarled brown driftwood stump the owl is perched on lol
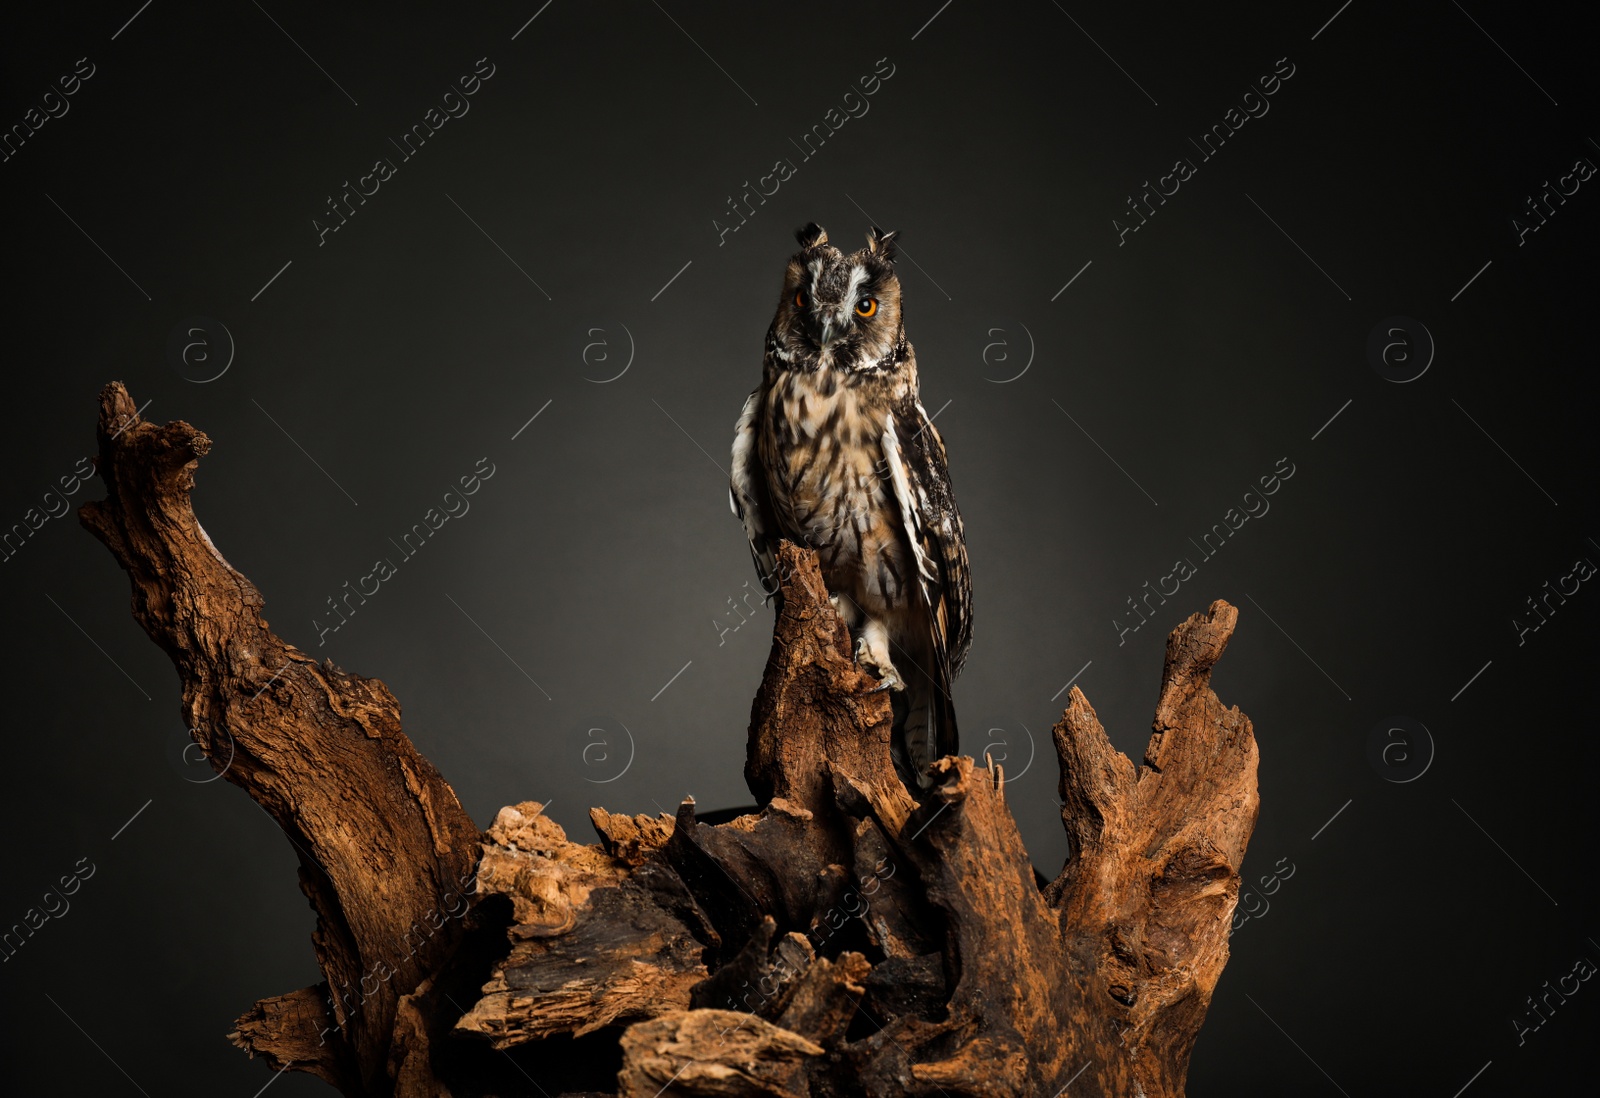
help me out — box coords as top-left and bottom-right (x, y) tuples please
(82, 384), (1258, 1098)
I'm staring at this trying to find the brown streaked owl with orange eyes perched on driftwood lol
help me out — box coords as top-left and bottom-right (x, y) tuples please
(728, 224), (973, 789)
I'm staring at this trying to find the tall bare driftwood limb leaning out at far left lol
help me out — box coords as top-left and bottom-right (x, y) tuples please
(78, 383), (478, 1093)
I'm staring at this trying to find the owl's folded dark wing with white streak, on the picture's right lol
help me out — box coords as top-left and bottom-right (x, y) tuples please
(882, 397), (973, 679)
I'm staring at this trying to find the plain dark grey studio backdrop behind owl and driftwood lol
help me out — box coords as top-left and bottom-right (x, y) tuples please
(0, 0), (1600, 1098)
